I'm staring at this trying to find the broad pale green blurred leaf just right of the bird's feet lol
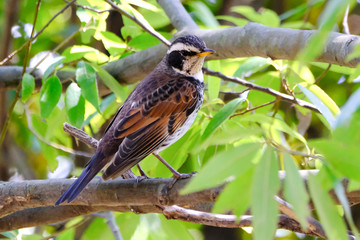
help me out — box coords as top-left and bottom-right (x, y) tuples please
(181, 143), (262, 194)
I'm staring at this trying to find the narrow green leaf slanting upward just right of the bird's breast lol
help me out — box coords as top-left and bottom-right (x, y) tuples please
(201, 98), (245, 142)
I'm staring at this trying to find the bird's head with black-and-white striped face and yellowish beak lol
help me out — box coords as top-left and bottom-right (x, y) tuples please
(166, 35), (215, 76)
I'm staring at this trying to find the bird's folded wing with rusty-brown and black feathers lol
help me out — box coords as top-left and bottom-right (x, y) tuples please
(103, 77), (201, 179)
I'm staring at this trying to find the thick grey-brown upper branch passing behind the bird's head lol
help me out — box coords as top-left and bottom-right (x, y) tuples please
(0, 23), (360, 87)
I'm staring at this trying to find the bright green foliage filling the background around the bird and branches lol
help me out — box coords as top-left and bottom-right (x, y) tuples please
(0, 0), (360, 239)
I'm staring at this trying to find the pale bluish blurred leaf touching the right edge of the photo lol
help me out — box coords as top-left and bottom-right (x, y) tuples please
(335, 88), (360, 128)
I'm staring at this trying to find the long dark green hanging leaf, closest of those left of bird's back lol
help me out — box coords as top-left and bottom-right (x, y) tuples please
(76, 61), (100, 112)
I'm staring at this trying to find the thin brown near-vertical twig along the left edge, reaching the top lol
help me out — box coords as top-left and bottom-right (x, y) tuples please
(0, 0), (41, 147)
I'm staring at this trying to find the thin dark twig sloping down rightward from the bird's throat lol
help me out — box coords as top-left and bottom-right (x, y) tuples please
(203, 68), (319, 113)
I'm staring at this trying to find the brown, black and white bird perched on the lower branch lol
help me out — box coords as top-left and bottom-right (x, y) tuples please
(55, 35), (215, 205)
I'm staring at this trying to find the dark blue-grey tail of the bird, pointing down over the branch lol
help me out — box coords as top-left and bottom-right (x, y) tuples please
(55, 152), (106, 206)
